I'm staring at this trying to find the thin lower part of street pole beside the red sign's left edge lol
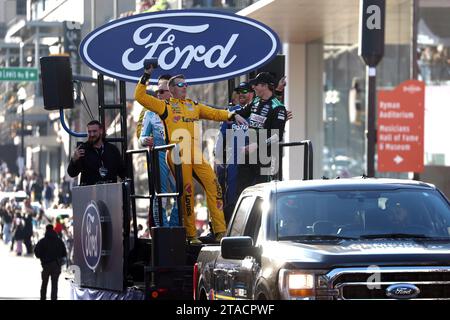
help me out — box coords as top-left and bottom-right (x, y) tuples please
(366, 66), (377, 178)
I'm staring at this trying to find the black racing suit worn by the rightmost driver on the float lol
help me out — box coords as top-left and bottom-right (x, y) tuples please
(236, 96), (287, 194)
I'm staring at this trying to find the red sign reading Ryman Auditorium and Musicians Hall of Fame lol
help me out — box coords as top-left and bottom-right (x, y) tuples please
(377, 80), (425, 172)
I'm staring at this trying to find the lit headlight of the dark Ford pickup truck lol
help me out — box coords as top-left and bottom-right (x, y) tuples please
(278, 269), (315, 300)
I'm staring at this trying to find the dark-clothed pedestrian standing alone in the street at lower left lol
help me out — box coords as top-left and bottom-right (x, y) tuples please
(34, 224), (67, 300)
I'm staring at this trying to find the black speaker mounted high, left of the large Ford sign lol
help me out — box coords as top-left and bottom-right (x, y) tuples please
(40, 56), (74, 110)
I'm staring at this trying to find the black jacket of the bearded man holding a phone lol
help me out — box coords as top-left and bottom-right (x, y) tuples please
(67, 142), (125, 185)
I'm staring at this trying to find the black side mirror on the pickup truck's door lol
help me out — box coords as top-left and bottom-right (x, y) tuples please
(220, 237), (259, 260)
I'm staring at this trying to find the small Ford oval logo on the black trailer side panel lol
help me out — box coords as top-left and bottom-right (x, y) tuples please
(81, 201), (102, 271)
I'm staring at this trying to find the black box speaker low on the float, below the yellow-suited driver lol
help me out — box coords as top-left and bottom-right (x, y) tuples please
(152, 227), (186, 267)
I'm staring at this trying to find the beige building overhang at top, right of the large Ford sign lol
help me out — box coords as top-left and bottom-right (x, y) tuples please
(238, 0), (412, 44)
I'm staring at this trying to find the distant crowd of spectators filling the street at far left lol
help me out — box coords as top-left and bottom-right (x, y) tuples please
(0, 160), (73, 264)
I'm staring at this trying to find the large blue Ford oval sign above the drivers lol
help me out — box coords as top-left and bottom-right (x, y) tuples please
(80, 10), (280, 84)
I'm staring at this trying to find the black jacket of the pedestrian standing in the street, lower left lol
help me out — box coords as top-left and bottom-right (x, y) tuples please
(34, 231), (67, 265)
